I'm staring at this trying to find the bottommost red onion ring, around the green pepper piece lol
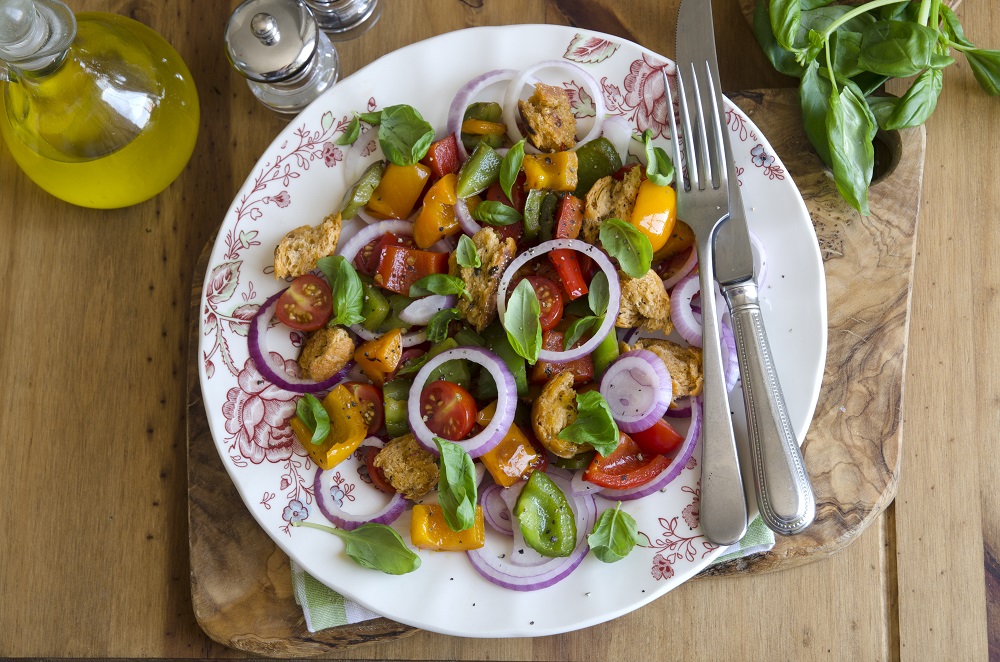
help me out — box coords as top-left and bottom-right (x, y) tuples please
(466, 472), (597, 591)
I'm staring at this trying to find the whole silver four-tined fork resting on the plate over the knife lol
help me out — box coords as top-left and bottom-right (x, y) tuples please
(663, 67), (747, 545)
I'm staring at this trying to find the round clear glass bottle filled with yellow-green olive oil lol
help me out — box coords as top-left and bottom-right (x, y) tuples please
(0, 0), (199, 209)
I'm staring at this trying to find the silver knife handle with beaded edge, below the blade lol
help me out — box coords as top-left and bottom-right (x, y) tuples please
(725, 281), (816, 535)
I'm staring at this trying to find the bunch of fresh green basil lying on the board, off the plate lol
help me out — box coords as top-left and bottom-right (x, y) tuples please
(753, 0), (1000, 215)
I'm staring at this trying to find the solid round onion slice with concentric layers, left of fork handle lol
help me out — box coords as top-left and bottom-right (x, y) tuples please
(601, 349), (674, 432)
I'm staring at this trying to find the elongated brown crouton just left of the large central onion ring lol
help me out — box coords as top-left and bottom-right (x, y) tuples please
(448, 228), (517, 331)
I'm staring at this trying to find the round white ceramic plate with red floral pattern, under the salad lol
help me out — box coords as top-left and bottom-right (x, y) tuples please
(200, 25), (826, 637)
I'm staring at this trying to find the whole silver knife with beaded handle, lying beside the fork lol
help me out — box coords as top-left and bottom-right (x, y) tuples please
(677, 0), (816, 535)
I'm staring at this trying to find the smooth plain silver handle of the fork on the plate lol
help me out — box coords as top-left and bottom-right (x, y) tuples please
(698, 240), (747, 545)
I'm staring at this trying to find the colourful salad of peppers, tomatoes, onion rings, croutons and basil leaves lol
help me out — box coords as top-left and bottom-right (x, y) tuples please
(249, 62), (748, 590)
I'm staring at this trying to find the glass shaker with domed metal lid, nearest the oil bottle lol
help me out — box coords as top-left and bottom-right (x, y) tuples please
(225, 0), (340, 115)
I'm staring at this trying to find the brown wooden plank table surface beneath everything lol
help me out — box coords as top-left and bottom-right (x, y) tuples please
(0, 0), (1000, 660)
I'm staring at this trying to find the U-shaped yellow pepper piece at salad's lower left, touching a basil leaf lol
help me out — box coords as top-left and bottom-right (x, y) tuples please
(289, 384), (368, 470)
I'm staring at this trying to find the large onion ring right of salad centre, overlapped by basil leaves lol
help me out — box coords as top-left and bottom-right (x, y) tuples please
(497, 239), (622, 363)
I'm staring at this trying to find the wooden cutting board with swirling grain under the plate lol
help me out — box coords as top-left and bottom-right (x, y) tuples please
(187, 90), (924, 657)
